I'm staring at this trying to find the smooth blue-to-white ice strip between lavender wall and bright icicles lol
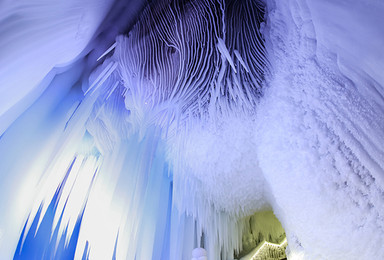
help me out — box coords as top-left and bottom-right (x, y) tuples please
(0, 62), (88, 259)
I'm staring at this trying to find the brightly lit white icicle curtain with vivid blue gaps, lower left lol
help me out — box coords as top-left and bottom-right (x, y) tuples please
(7, 71), (174, 259)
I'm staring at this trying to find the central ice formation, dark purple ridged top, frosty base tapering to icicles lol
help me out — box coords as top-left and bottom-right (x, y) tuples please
(89, 1), (268, 259)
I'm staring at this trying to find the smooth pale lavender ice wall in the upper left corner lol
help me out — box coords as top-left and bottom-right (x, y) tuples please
(0, 0), (112, 133)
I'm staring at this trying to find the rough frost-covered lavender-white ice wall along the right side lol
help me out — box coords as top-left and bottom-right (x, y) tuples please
(257, 1), (384, 259)
